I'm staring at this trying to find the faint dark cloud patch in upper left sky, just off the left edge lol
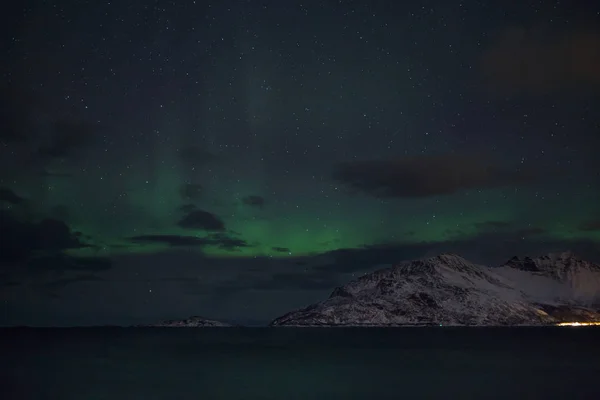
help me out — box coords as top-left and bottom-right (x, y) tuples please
(38, 120), (101, 159)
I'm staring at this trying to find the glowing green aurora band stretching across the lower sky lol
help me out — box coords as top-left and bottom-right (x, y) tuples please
(7, 154), (600, 257)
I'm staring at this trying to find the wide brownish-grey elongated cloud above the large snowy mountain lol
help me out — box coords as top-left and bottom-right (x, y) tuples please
(333, 155), (535, 198)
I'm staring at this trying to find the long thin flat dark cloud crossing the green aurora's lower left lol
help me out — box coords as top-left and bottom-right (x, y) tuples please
(129, 233), (249, 251)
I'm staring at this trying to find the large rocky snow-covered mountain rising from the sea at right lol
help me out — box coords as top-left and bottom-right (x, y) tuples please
(271, 253), (600, 326)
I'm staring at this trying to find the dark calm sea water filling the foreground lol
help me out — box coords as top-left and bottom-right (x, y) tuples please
(0, 328), (600, 400)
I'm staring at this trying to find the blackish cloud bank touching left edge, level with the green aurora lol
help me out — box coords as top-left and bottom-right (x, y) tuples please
(0, 210), (89, 263)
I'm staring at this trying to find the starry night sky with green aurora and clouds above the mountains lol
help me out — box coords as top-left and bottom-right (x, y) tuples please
(0, 0), (600, 325)
